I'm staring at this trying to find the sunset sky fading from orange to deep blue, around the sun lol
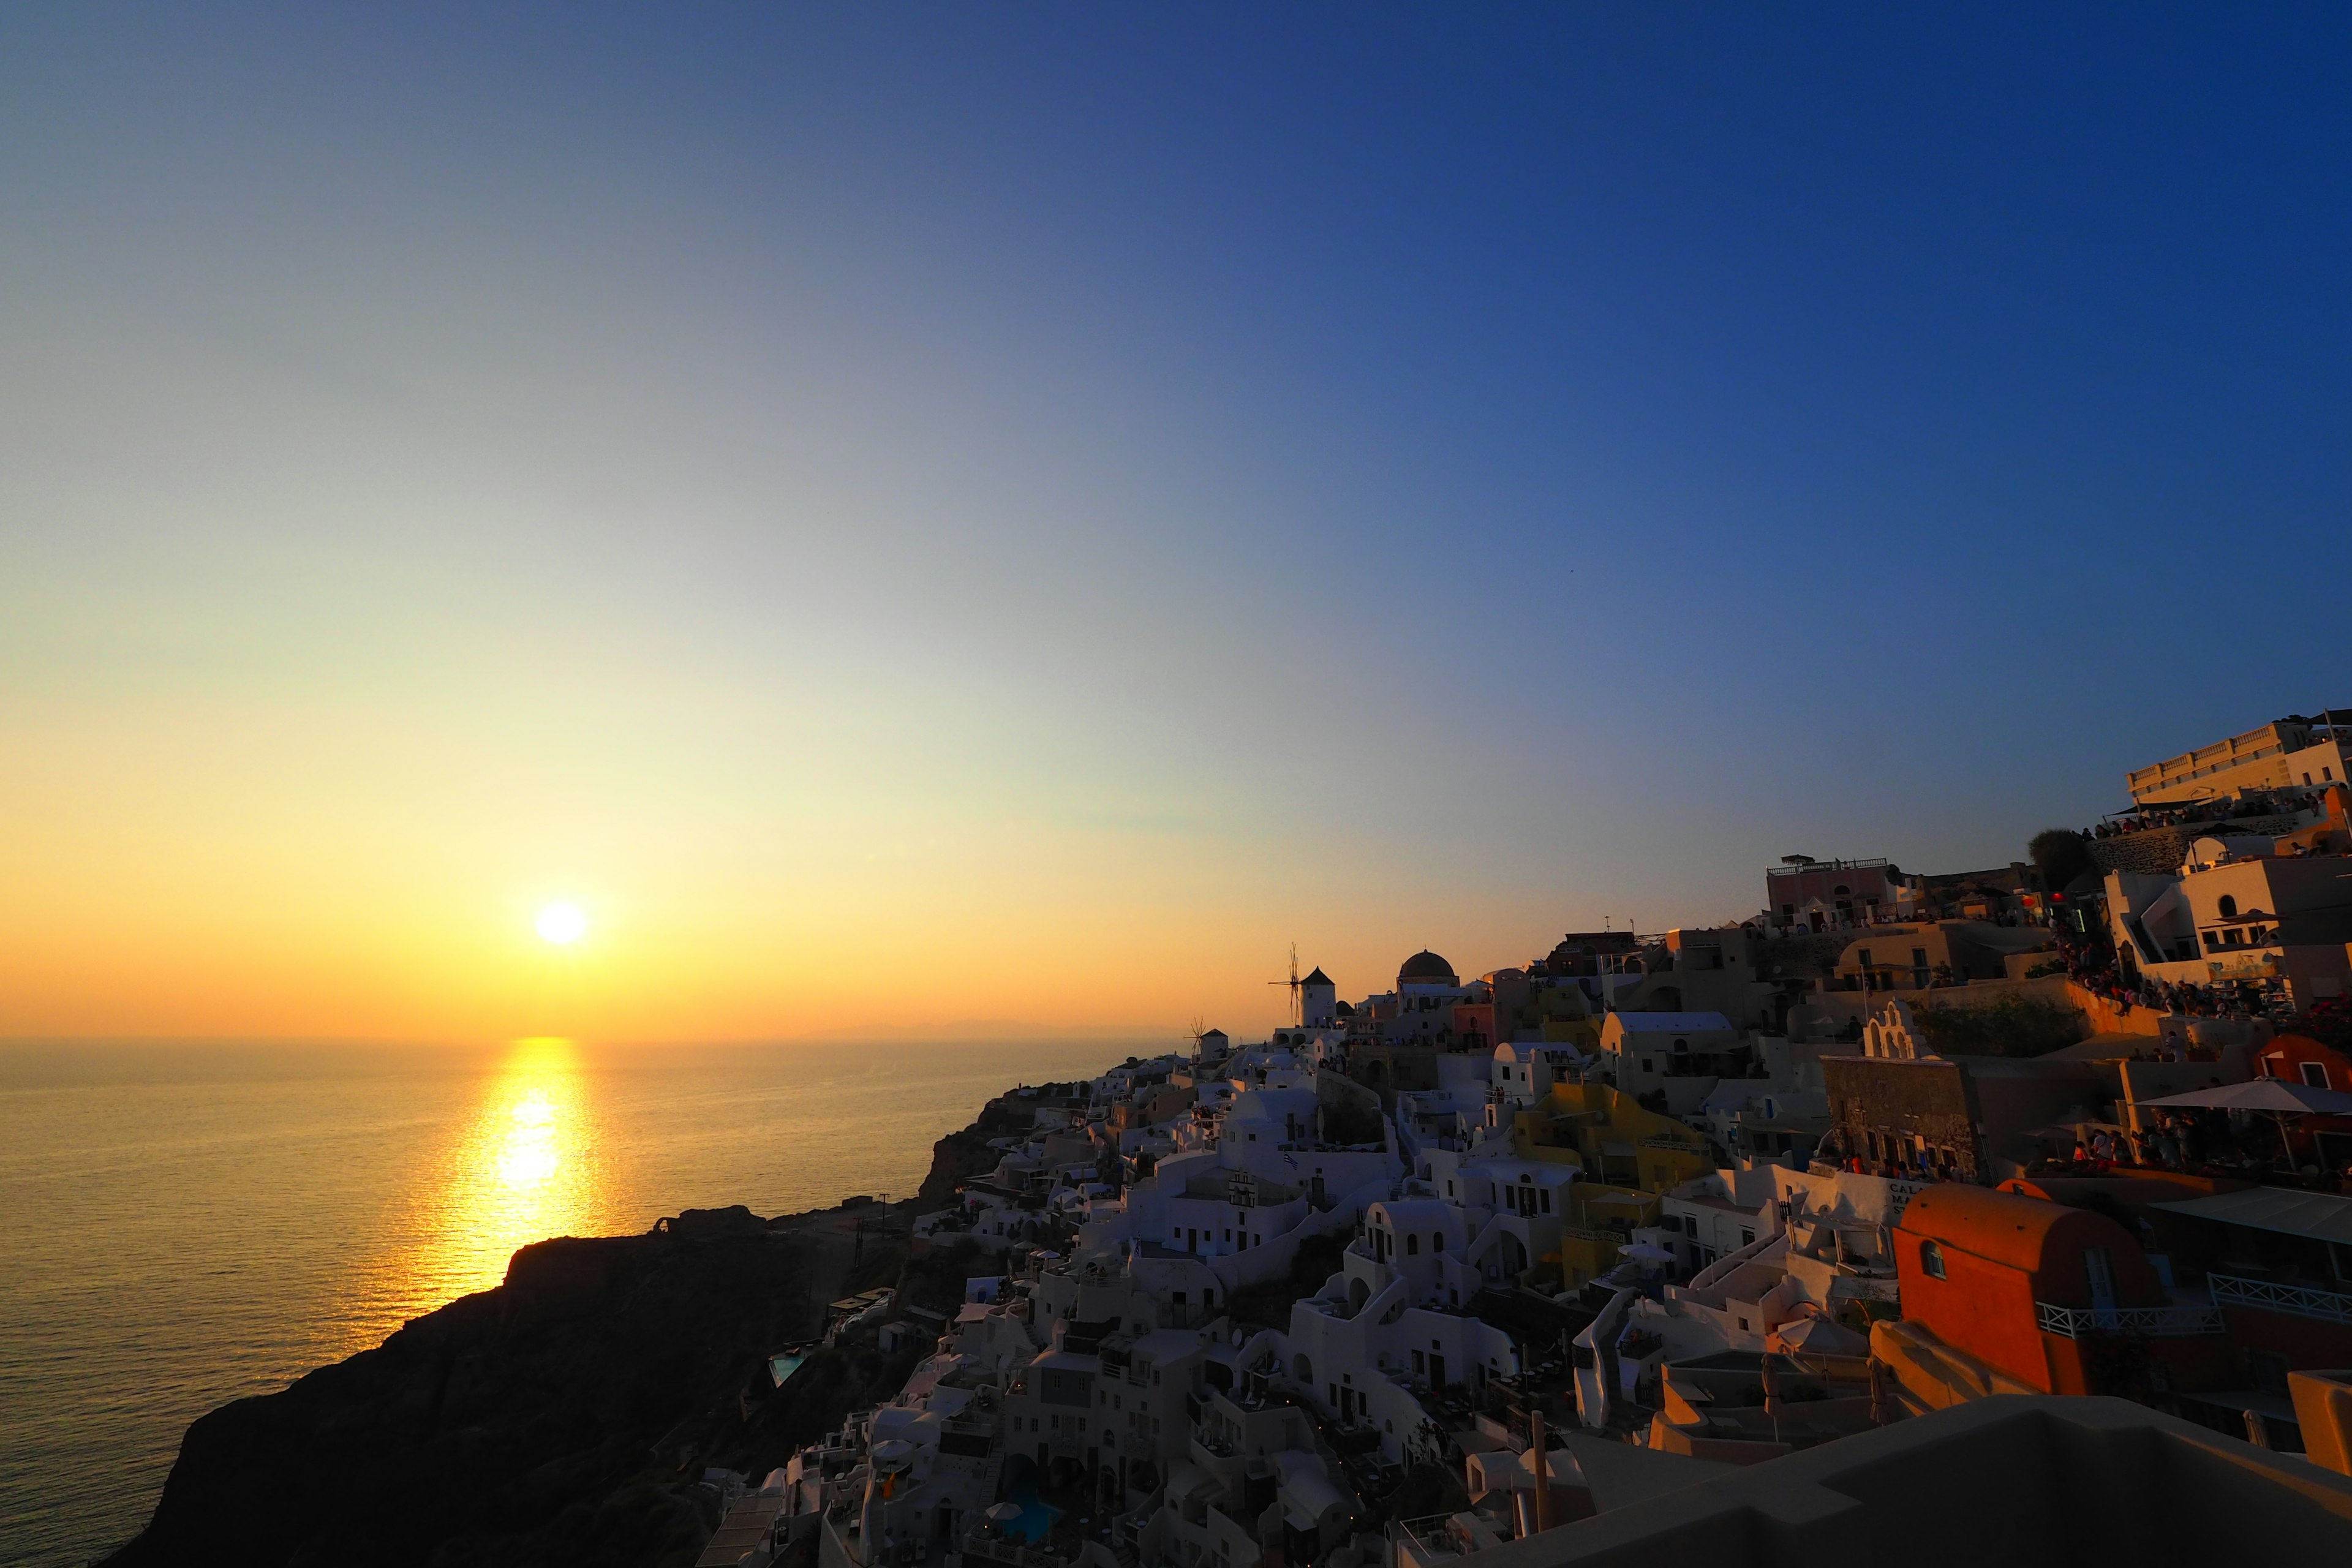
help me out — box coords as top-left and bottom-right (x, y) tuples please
(0, 5), (2352, 1039)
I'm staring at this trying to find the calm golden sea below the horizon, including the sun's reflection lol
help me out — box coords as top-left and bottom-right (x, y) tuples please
(0, 1041), (1143, 1566)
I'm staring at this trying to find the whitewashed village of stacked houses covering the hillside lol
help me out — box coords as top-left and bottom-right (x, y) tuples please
(703, 712), (2352, 1568)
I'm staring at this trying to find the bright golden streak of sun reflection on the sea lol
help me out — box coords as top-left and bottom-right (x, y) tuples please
(402, 1039), (611, 1314)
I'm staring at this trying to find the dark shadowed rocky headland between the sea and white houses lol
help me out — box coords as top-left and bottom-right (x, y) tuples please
(104, 1100), (1025, 1568)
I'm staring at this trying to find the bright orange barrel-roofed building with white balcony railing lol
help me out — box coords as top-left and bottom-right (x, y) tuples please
(1893, 1183), (2230, 1396)
